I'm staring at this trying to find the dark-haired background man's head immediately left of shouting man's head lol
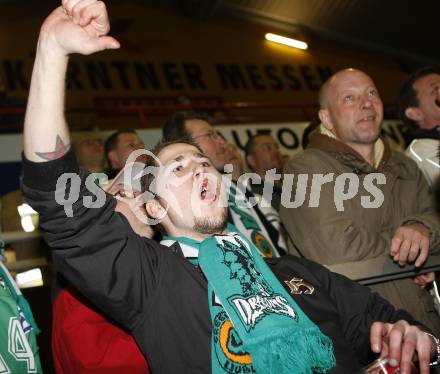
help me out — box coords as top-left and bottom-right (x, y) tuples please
(104, 129), (145, 179)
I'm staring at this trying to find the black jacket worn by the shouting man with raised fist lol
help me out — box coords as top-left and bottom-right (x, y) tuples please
(23, 152), (415, 374)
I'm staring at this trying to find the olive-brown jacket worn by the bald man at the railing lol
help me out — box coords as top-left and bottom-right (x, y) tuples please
(280, 132), (440, 333)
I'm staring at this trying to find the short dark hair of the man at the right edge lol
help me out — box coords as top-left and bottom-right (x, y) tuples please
(397, 66), (440, 130)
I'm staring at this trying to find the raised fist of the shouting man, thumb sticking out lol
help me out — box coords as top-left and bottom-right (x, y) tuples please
(39, 0), (119, 56)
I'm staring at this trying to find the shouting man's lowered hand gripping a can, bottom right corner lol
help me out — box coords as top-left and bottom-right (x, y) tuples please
(370, 320), (436, 374)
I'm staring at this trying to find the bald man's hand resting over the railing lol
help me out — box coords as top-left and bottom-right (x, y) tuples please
(390, 223), (429, 267)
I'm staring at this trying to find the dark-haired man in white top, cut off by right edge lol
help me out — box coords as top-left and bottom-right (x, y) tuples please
(397, 66), (440, 187)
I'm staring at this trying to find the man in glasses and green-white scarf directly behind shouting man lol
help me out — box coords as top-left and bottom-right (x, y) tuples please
(162, 111), (286, 257)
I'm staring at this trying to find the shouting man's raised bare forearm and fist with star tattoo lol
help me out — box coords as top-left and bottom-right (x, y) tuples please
(24, 0), (119, 162)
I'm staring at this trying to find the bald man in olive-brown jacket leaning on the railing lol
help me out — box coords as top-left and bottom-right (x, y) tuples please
(280, 69), (440, 332)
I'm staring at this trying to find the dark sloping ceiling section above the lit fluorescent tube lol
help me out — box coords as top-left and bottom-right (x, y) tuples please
(173, 0), (440, 64)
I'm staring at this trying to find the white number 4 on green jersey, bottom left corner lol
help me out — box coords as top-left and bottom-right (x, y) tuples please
(8, 317), (37, 373)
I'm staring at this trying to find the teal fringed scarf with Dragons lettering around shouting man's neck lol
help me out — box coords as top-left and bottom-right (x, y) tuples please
(163, 225), (335, 374)
